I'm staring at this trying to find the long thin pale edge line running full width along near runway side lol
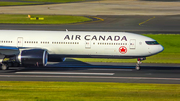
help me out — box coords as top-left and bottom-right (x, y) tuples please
(0, 75), (180, 81)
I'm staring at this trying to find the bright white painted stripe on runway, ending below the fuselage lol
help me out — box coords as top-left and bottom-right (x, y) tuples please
(16, 72), (114, 75)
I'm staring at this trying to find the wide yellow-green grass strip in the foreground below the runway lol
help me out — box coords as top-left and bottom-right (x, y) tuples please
(0, 81), (180, 101)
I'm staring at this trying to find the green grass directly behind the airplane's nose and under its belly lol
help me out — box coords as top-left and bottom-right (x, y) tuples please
(75, 34), (180, 63)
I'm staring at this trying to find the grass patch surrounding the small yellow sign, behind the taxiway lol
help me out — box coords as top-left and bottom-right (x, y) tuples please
(0, 14), (92, 24)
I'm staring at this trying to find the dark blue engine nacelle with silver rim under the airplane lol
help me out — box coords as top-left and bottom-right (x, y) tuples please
(17, 49), (48, 66)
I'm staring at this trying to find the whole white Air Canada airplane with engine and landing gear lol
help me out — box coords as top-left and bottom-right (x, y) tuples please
(0, 30), (164, 70)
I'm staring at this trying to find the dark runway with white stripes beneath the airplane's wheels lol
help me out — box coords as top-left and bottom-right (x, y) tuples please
(0, 62), (180, 84)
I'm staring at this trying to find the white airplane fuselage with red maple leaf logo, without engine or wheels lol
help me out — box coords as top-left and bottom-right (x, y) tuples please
(0, 30), (163, 58)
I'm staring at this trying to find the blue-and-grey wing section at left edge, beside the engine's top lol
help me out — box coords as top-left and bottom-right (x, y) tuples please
(0, 46), (19, 55)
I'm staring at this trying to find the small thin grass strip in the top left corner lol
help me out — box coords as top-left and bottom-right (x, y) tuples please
(0, 2), (40, 6)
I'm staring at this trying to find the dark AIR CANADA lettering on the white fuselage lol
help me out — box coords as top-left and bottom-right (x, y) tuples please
(64, 35), (127, 41)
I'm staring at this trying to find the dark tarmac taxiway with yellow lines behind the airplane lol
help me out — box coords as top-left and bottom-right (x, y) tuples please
(0, 15), (180, 34)
